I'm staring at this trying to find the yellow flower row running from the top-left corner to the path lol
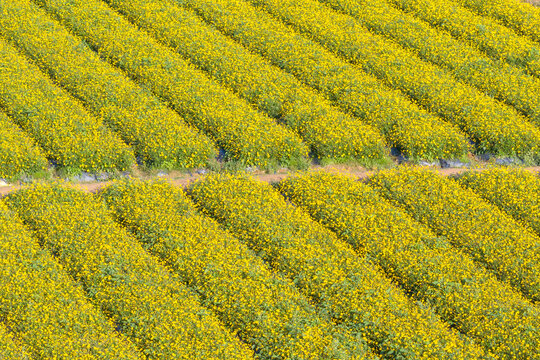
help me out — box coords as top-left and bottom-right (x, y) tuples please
(0, 0), (217, 168)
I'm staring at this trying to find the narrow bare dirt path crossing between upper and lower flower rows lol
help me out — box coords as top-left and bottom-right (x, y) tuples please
(0, 166), (540, 197)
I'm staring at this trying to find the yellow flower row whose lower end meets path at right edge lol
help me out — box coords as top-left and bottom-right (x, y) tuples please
(243, 0), (540, 156)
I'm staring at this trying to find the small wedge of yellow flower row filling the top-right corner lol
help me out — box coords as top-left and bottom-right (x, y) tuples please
(453, 0), (540, 42)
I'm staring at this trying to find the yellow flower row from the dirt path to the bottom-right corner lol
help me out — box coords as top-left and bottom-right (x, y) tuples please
(279, 173), (540, 359)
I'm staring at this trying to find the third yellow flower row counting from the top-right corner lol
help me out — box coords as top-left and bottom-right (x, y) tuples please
(321, 0), (540, 125)
